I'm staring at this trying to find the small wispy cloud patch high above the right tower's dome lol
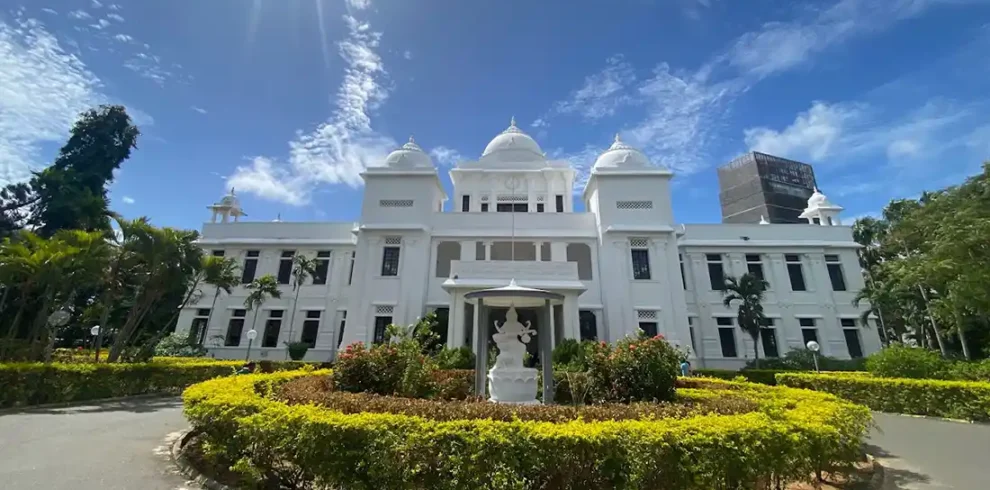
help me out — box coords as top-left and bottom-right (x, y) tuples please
(554, 56), (636, 120)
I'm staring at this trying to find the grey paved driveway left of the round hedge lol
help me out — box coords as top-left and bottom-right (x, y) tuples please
(0, 398), (199, 490)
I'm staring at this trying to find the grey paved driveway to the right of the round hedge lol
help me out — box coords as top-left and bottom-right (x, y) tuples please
(867, 413), (990, 490)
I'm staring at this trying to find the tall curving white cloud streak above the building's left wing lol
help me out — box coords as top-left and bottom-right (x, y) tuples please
(228, 11), (396, 205)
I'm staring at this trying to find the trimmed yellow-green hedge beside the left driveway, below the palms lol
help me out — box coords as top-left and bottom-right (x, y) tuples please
(0, 359), (243, 408)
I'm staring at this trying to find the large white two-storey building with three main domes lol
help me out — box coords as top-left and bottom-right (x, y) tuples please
(179, 123), (880, 368)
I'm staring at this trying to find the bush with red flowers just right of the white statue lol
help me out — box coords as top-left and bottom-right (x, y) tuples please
(588, 335), (681, 403)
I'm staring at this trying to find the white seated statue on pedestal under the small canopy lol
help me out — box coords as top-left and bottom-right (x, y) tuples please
(488, 307), (538, 404)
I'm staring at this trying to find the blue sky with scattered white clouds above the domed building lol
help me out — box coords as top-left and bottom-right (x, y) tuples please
(0, 0), (990, 228)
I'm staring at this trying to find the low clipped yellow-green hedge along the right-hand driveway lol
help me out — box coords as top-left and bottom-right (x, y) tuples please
(777, 373), (990, 421)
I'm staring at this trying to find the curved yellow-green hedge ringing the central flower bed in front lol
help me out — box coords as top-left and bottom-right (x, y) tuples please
(183, 371), (870, 490)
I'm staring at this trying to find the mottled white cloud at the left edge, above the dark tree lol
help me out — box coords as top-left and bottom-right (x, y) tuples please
(0, 18), (104, 185)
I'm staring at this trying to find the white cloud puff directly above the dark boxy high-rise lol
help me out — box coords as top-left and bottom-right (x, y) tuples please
(744, 102), (862, 162)
